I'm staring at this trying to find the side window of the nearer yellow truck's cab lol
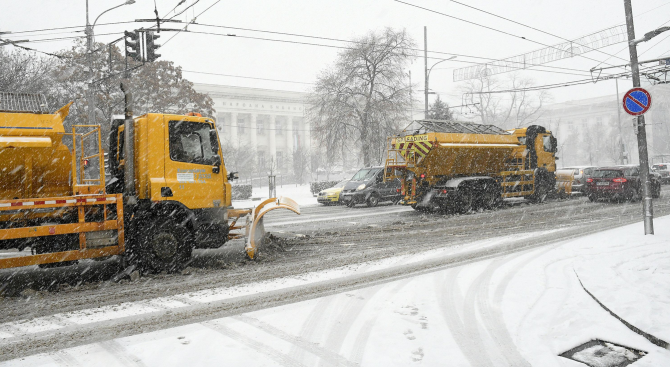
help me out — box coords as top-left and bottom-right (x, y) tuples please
(169, 121), (218, 164)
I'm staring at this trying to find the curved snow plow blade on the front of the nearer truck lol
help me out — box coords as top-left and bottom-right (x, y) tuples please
(244, 196), (300, 260)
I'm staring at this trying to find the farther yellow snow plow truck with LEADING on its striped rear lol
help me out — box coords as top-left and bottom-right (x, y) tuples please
(384, 120), (558, 212)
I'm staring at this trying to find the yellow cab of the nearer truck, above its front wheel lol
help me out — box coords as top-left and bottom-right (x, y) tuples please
(108, 113), (232, 253)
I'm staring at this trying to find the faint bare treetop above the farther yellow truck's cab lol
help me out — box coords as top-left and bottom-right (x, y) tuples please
(463, 73), (551, 129)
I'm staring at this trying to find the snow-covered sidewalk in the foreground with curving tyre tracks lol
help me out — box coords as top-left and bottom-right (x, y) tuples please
(5, 216), (670, 366)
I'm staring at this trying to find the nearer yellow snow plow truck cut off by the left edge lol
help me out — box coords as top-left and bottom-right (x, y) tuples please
(0, 91), (300, 271)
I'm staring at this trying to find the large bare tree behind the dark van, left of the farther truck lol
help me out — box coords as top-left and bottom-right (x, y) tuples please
(307, 28), (414, 166)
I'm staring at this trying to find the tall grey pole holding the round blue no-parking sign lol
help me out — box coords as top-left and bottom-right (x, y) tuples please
(623, 0), (654, 235)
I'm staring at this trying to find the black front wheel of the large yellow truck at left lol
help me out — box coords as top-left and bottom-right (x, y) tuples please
(131, 217), (193, 273)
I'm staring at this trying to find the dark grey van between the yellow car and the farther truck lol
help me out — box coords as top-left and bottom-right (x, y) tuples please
(340, 167), (402, 207)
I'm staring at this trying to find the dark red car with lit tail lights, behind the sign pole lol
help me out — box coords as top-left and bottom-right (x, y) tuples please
(586, 166), (661, 201)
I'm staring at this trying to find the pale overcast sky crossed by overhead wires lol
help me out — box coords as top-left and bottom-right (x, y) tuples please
(0, 0), (670, 113)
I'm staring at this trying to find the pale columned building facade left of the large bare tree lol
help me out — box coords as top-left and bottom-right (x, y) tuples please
(194, 83), (312, 171)
